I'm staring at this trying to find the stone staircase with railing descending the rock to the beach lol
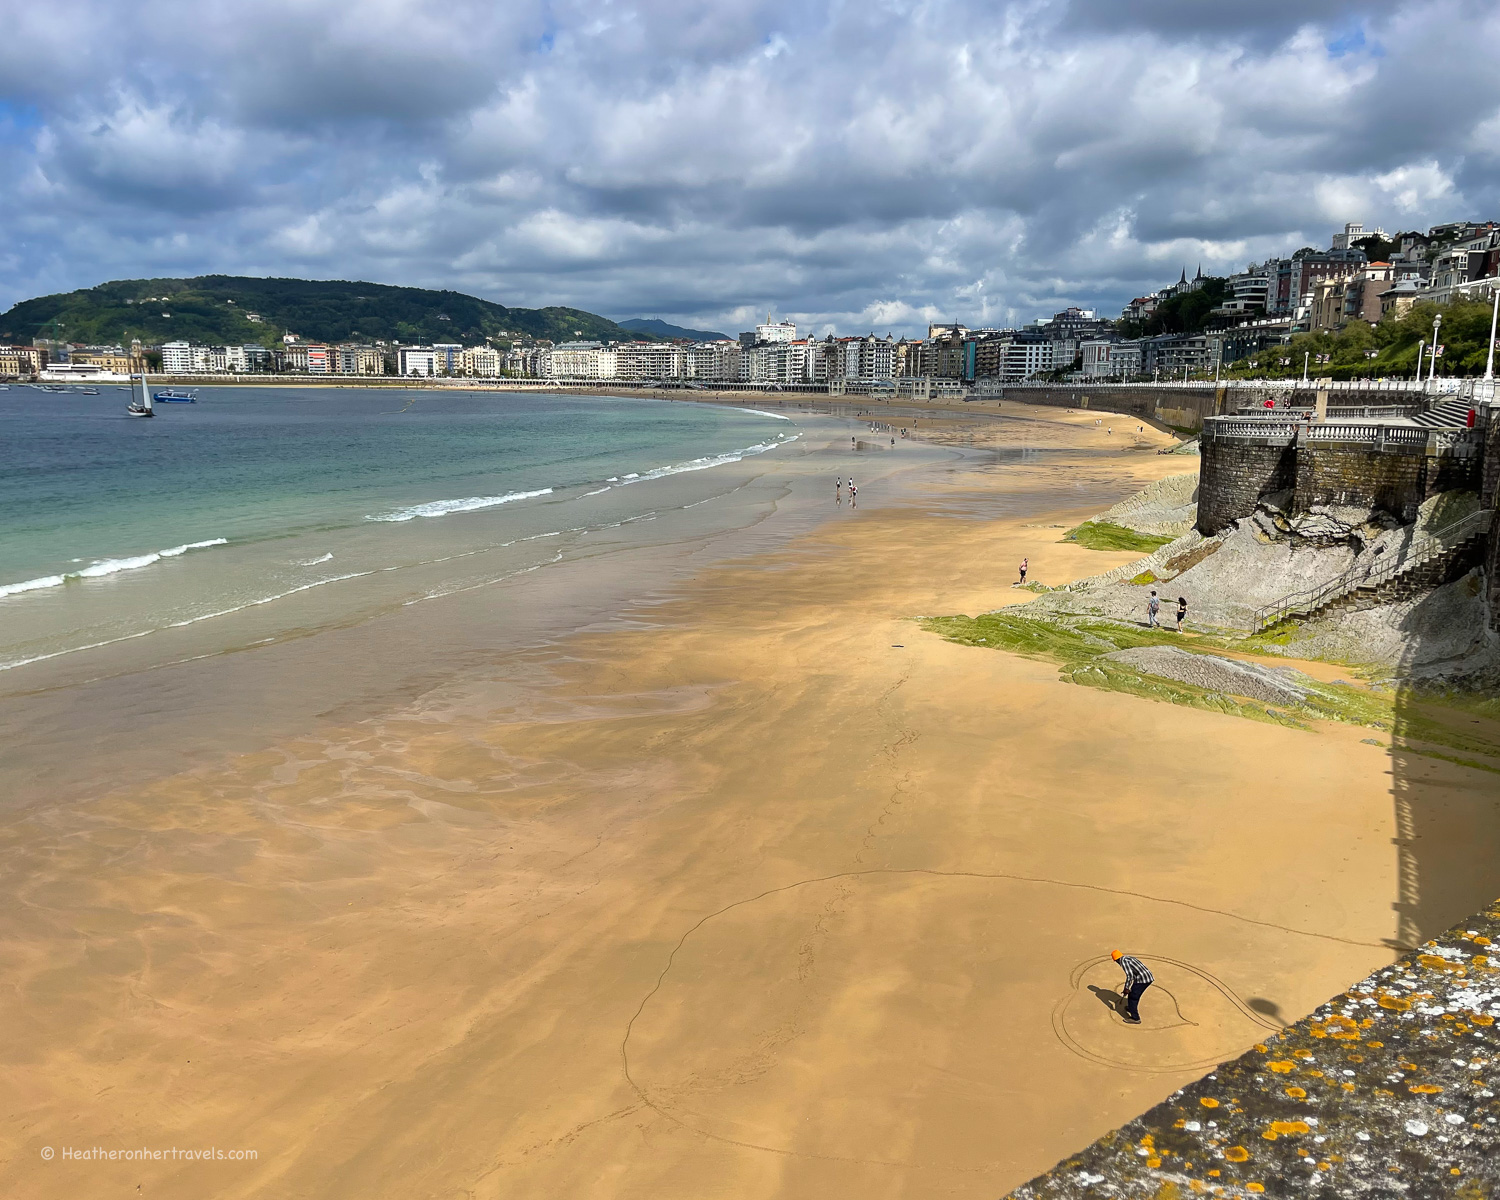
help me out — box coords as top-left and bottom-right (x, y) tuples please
(1251, 510), (1494, 633)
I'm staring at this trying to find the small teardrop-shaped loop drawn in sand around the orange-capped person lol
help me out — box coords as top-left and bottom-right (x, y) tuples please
(1052, 954), (1281, 1074)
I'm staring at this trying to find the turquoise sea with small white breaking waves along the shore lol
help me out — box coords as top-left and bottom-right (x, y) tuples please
(0, 387), (798, 681)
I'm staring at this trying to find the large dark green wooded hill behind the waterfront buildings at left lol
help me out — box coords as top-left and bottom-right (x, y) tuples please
(0, 275), (650, 345)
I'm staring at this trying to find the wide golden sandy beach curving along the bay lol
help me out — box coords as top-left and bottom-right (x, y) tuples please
(0, 402), (1500, 1200)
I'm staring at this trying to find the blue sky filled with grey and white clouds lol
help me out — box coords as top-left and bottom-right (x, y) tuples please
(0, 0), (1500, 335)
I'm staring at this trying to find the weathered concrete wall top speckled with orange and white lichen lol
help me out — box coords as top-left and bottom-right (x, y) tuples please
(1011, 902), (1500, 1200)
